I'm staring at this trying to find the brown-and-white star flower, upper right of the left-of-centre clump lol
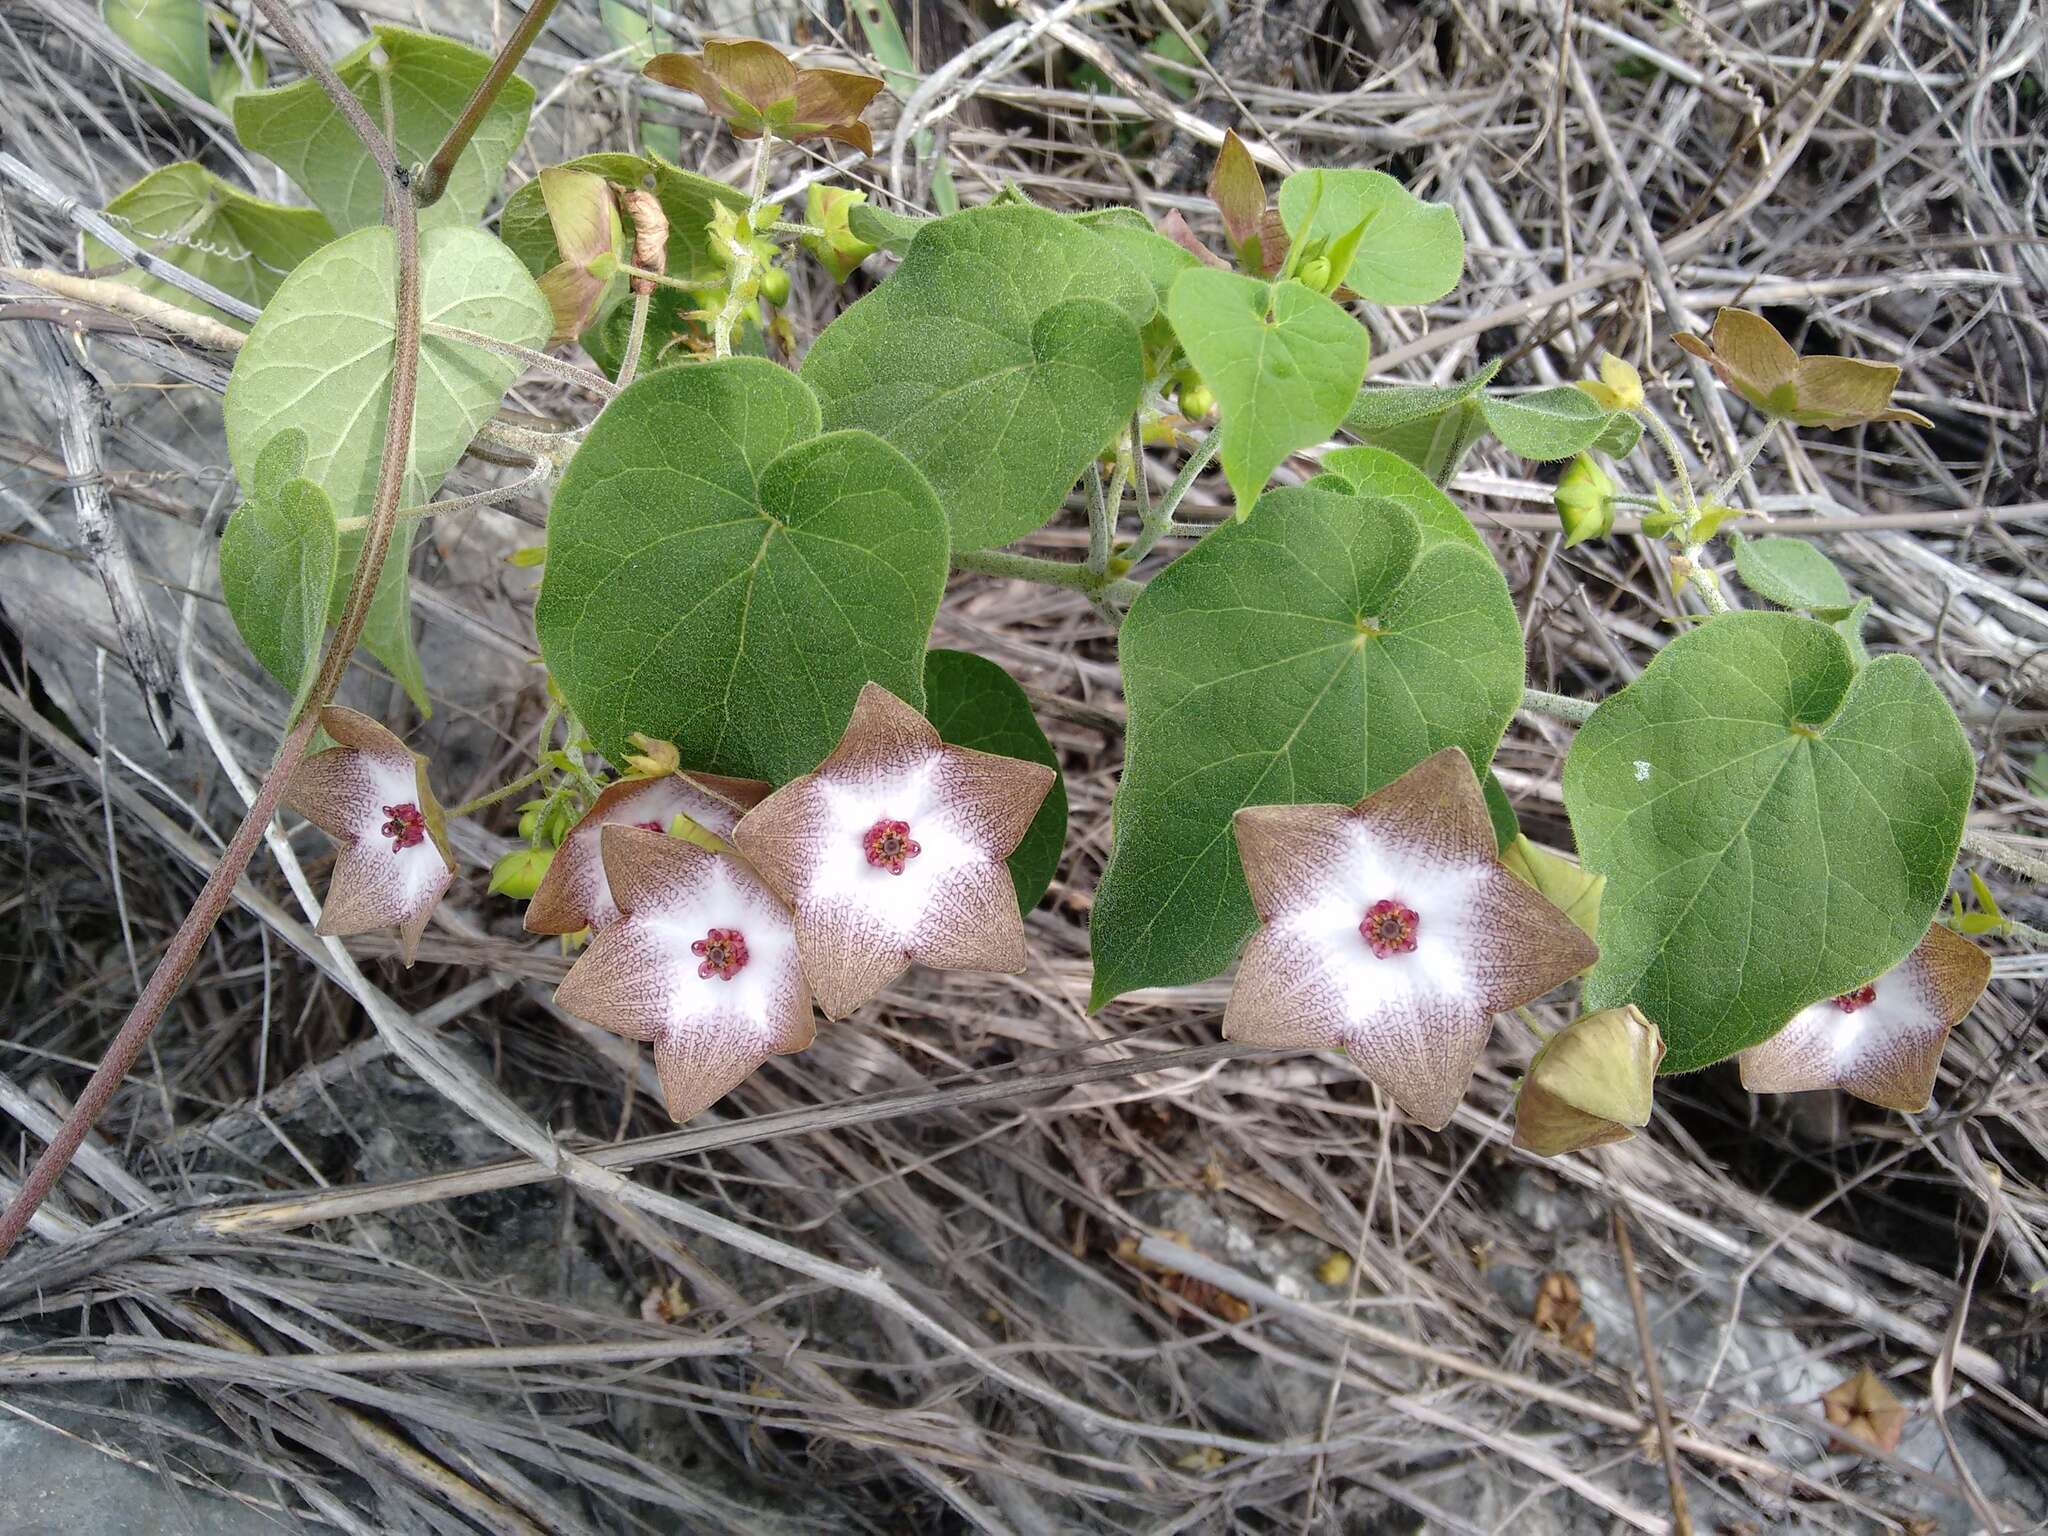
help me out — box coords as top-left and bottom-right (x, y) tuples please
(733, 682), (1053, 1018)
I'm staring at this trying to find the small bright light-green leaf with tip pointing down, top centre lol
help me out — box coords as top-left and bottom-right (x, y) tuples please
(1165, 266), (1370, 518)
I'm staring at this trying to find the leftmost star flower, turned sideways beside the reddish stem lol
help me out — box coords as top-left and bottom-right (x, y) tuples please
(285, 705), (455, 965)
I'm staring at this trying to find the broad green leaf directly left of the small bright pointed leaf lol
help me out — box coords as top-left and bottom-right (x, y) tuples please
(803, 205), (1155, 549)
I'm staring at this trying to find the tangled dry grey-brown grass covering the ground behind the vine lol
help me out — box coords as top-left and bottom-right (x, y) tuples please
(0, 0), (2048, 1532)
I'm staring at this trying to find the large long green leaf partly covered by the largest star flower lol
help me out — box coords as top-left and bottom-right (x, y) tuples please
(1090, 449), (1522, 1006)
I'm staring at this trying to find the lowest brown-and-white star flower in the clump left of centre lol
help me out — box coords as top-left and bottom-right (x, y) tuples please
(555, 823), (811, 1124)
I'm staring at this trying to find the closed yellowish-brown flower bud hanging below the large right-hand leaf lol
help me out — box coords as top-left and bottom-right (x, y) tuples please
(1516, 1008), (1663, 1157)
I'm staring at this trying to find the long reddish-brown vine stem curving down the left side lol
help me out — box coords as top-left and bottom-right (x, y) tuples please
(0, 0), (432, 1257)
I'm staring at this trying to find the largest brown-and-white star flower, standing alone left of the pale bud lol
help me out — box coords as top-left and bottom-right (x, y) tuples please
(1223, 748), (1599, 1130)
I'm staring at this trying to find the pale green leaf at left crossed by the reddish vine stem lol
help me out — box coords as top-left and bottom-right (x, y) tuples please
(221, 227), (551, 709)
